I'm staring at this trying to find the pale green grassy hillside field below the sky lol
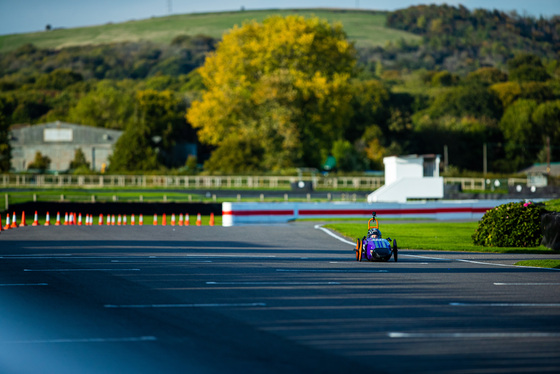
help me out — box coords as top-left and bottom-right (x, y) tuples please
(0, 9), (420, 53)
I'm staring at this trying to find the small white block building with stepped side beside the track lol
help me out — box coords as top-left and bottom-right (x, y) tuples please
(368, 155), (443, 203)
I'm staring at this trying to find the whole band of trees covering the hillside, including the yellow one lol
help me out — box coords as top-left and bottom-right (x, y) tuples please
(0, 5), (560, 173)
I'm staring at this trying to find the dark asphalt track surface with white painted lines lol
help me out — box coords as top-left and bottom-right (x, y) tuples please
(0, 223), (560, 374)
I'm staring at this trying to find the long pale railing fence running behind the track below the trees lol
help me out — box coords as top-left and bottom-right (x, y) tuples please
(0, 174), (527, 191)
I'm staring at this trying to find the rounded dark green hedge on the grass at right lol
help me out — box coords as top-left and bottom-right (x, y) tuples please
(472, 202), (546, 247)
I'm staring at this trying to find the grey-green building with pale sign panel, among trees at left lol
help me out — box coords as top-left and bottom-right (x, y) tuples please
(10, 121), (123, 172)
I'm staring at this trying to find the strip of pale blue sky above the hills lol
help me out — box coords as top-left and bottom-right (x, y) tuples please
(0, 0), (560, 35)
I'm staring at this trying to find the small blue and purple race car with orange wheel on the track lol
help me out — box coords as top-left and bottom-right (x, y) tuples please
(356, 212), (399, 262)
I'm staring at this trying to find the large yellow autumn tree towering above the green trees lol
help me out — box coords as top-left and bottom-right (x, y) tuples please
(186, 16), (356, 172)
